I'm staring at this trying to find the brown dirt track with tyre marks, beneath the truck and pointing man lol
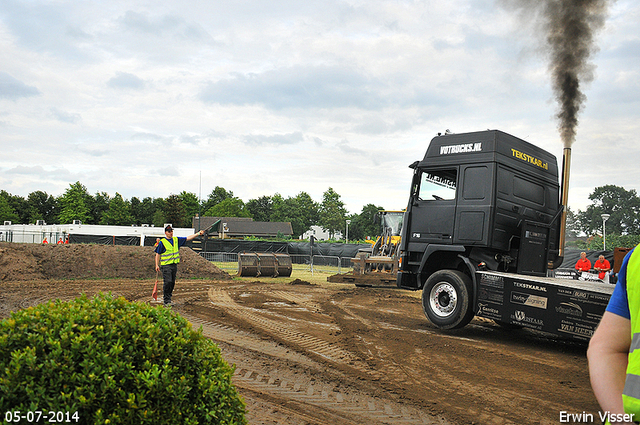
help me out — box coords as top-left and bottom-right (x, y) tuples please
(0, 243), (598, 425)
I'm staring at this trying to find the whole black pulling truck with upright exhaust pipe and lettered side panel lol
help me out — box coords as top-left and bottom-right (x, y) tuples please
(397, 130), (613, 339)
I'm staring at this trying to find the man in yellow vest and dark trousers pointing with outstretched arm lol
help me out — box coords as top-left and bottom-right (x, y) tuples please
(155, 225), (204, 307)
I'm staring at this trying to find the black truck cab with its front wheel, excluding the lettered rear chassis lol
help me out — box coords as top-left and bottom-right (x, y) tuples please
(397, 130), (563, 327)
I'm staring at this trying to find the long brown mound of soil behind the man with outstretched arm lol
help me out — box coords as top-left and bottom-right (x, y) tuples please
(0, 242), (231, 281)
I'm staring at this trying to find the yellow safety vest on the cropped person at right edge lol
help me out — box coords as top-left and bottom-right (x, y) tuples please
(622, 248), (640, 420)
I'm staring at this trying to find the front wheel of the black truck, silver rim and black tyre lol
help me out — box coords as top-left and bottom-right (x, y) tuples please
(422, 270), (474, 329)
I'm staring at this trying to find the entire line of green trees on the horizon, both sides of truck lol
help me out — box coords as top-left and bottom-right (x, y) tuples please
(0, 182), (640, 245)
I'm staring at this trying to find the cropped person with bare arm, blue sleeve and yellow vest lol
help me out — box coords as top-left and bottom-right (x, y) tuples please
(587, 248), (640, 425)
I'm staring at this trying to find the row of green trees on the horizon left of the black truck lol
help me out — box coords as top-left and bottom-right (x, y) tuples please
(0, 182), (383, 240)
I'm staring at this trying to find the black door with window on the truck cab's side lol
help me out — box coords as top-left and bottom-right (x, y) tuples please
(407, 168), (458, 244)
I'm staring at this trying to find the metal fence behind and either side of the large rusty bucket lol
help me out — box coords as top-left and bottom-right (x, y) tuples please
(200, 252), (352, 273)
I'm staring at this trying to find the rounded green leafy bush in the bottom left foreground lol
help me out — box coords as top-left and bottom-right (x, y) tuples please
(0, 294), (246, 424)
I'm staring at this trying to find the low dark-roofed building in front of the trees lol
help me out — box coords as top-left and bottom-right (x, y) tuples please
(193, 217), (293, 238)
